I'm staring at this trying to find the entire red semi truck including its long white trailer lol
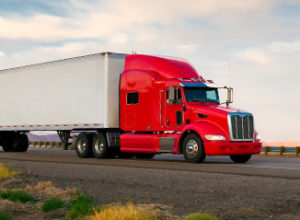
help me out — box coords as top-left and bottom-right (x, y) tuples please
(0, 52), (261, 163)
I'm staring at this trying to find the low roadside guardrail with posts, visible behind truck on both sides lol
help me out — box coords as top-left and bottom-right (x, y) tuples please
(29, 141), (300, 156)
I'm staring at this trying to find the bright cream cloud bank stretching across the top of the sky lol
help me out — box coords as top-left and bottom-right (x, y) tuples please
(0, 0), (269, 41)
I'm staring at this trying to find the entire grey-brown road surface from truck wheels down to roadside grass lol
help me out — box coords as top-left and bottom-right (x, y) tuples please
(0, 149), (300, 220)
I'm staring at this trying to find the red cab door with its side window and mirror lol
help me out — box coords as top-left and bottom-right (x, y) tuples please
(164, 86), (184, 129)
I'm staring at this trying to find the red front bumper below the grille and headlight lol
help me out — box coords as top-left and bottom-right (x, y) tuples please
(203, 141), (262, 155)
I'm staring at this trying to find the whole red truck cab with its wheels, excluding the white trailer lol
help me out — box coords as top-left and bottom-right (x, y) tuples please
(120, 55), (261, 163)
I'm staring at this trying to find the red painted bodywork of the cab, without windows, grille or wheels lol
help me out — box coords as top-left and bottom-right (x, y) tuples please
(120, 55), (261, 155)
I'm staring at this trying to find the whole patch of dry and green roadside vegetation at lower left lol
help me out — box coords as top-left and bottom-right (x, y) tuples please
(0, 163), (216, 220)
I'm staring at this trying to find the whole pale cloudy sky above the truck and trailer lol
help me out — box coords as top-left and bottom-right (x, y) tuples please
(0, 0), (300, 141)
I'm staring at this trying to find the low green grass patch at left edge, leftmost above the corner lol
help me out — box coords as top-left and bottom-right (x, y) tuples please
(0, 190), (35, 203)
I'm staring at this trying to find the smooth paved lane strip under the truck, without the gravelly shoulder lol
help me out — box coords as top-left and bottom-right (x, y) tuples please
(0, 149), (300, 179)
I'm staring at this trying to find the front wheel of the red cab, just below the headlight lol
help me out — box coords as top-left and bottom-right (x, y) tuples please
(182, 133), (206, 163)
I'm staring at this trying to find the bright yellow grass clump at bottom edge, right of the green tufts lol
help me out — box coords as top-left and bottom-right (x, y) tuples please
(89, 204), (157, 220)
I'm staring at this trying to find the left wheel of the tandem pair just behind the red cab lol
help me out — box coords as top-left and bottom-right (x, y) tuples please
(74, 133), (93, 158)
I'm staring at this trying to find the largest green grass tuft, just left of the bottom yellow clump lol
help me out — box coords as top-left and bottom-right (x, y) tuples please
(66, 194), (95, 219)
